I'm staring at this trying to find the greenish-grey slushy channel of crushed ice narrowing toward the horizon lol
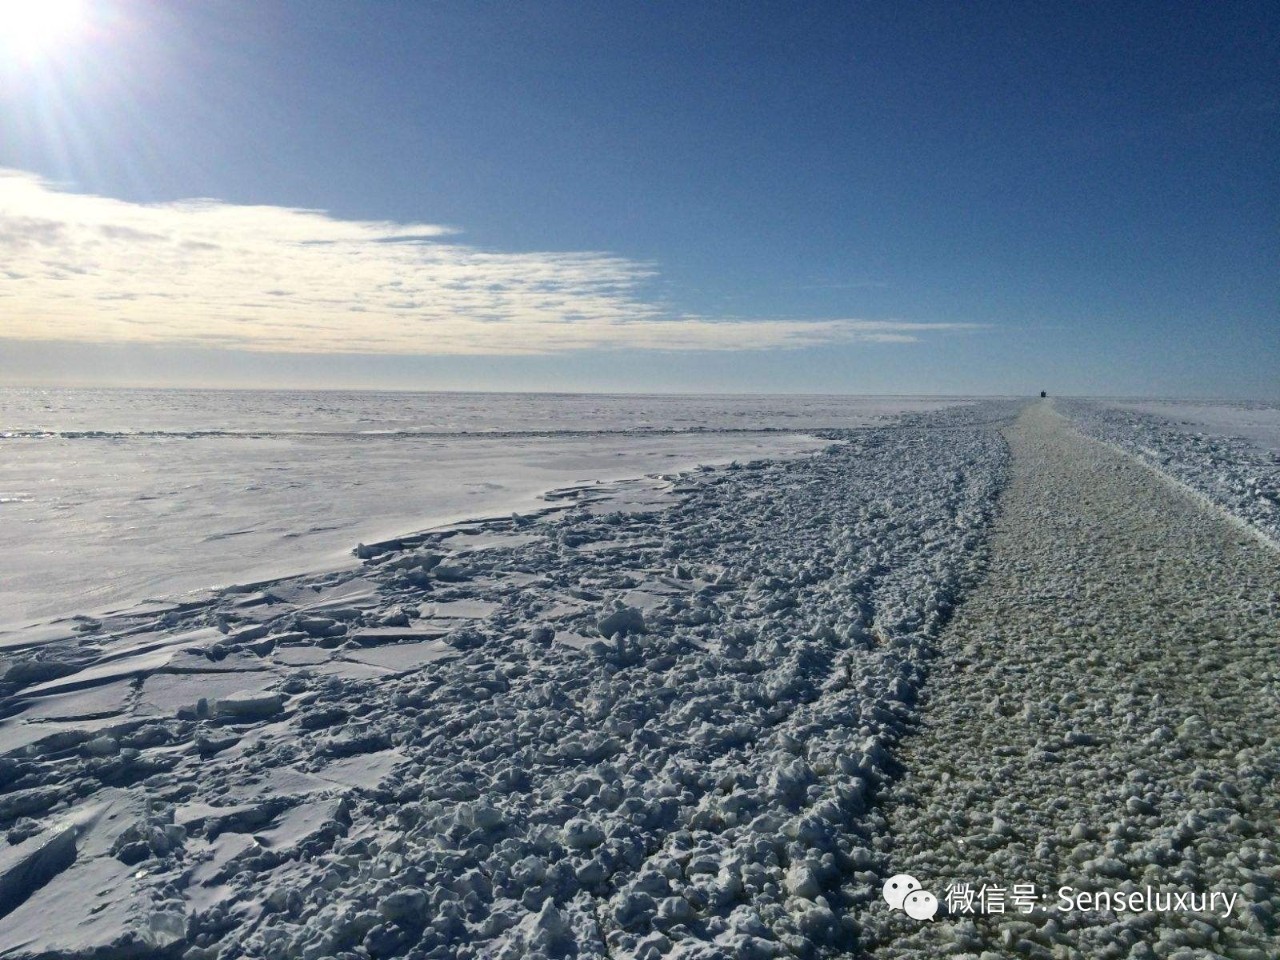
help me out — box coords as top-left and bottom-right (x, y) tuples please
(864, 404), (1280, 960)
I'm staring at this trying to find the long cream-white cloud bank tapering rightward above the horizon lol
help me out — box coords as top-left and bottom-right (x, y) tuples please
(0, 170), (978, 355)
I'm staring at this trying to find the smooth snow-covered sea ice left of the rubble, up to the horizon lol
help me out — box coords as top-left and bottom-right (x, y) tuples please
(0, 388), (963, 627)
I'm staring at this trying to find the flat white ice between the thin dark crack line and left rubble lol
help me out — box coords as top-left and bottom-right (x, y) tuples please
(0, 434), (826, 622)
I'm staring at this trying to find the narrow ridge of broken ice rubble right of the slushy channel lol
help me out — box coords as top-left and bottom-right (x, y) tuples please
(1055, 399), (1280, 548)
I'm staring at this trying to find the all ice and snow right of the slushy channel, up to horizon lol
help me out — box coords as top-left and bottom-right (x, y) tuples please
(1055, 399), (1280, 545)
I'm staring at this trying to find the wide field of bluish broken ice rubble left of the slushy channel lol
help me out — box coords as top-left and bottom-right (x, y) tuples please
(0, 402), (1015, 960)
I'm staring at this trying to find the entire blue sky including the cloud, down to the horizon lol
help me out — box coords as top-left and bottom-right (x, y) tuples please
(0, 0), (1280, 398)
